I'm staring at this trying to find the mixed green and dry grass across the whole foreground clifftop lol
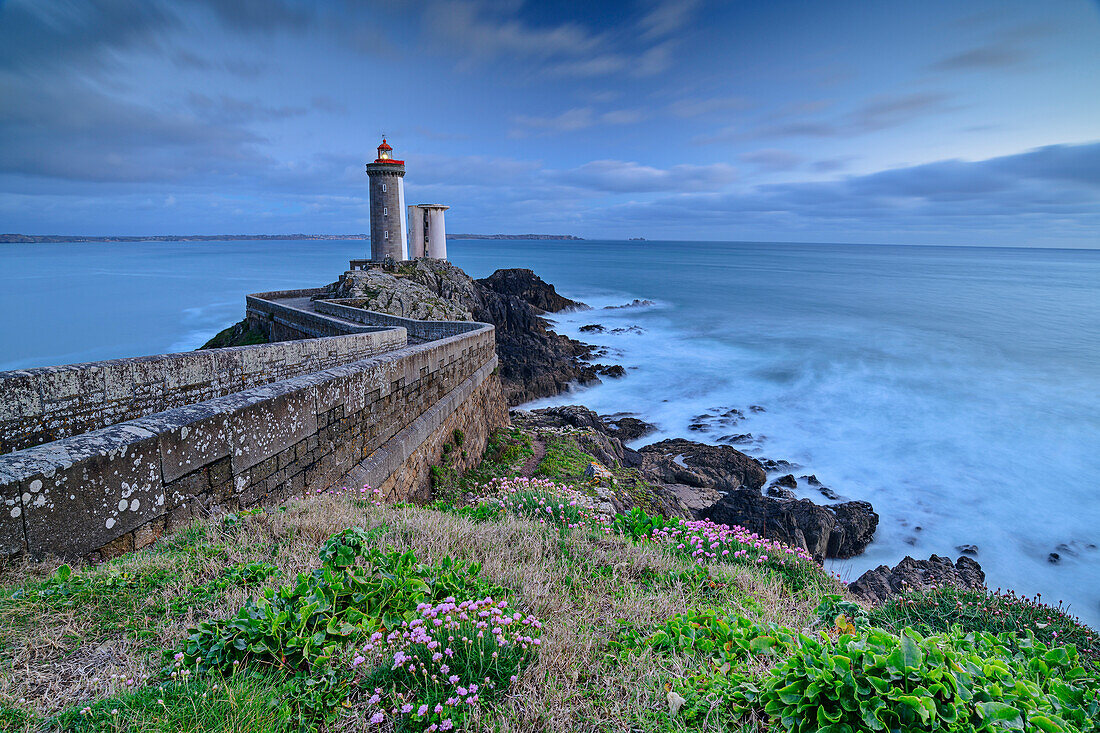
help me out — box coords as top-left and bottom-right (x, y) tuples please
(0, 430), (1092, 733)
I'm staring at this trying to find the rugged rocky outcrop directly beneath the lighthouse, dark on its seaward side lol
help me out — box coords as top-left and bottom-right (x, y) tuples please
(318, 259), (600, 405)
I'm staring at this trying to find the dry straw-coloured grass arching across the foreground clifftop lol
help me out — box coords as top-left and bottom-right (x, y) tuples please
(0, 495), (817, 732)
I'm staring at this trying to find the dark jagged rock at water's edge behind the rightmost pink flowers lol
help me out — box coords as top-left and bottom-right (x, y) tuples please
(702, 489), (879, 561)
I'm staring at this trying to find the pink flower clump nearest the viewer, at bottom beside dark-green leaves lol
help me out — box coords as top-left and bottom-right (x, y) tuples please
(351, 598), (542, 733)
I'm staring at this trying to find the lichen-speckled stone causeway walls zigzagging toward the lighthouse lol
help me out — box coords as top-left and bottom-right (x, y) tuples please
(0, 291), (508, 558)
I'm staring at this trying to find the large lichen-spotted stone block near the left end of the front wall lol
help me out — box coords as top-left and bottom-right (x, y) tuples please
(21, 424), (165, 557)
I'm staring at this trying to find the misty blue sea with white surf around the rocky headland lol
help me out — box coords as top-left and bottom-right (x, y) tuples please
(0, 240), (1100, 626)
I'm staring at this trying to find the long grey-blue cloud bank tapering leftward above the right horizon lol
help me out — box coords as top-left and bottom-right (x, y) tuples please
(604, 142), (1100, 236)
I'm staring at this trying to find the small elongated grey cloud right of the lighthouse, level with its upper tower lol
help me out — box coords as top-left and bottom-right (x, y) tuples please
(547, 161), (737, 194)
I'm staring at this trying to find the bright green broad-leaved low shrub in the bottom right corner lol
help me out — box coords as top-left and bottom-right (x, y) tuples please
(645, 610), (1100, 733)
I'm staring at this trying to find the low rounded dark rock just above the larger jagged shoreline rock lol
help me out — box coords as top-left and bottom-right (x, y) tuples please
(640, 438), (768, 491)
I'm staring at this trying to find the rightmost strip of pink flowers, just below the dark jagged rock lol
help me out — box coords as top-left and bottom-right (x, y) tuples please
(652, 512), (813, 566)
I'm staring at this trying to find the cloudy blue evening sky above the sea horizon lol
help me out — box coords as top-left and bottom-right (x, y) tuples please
(0, 0), (1100, 247)
